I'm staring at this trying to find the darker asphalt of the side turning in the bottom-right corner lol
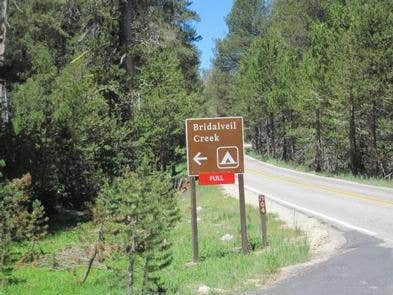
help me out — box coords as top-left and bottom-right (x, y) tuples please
(250, 232), (393, 295)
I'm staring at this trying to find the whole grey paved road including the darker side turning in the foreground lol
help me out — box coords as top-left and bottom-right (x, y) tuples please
(245, 157), (393, 295)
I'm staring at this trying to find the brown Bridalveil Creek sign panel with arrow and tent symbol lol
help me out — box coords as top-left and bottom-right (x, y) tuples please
(186, 117), (244, 176)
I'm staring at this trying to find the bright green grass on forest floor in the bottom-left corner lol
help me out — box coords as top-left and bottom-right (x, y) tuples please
(0, 222), (124, 295)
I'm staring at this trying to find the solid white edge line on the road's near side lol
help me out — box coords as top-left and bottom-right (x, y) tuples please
(244, 185), (377, 237)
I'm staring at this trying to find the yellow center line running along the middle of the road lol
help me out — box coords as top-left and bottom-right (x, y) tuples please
(246, 169), (393, 206)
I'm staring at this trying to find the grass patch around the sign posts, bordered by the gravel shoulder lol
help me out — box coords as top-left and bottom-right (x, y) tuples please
(164, 187), (309, 294)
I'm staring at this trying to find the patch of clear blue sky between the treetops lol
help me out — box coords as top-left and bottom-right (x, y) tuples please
(191, 0), (233, 70)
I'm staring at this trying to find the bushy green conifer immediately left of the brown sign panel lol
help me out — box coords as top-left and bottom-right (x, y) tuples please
(134, 48), (197, 170)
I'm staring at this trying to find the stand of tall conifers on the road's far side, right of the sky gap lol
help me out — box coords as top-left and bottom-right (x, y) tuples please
(204, 0), (393, 183)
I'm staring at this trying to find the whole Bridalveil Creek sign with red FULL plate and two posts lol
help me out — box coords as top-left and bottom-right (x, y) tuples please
(186, 117), (248, 262)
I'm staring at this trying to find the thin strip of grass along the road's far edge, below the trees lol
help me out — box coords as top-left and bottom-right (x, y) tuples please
(246, 148), (393, 188)
